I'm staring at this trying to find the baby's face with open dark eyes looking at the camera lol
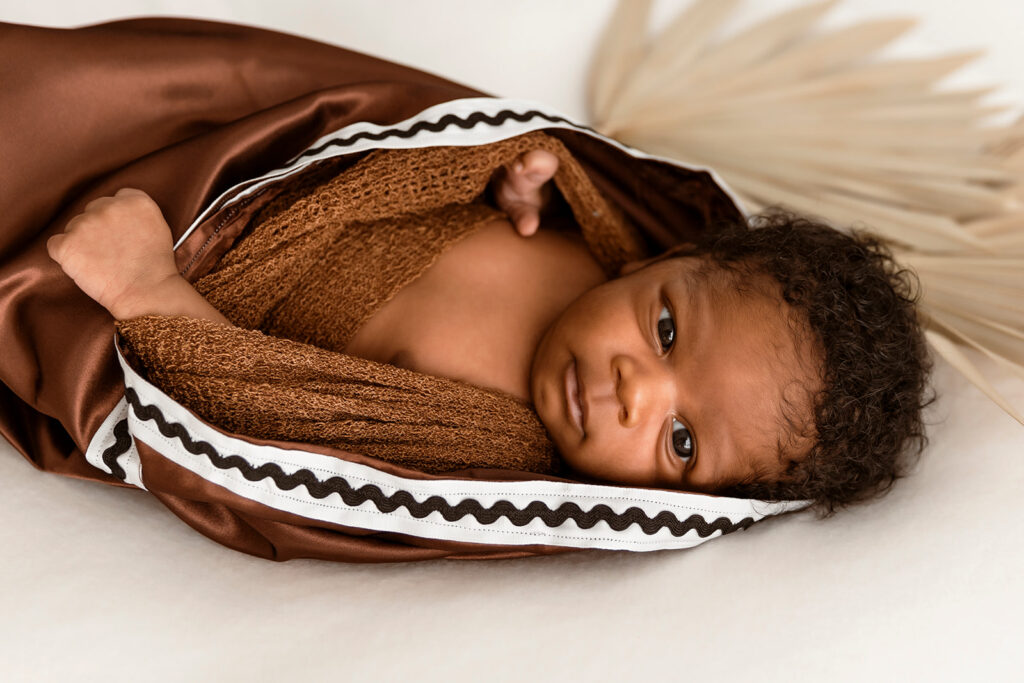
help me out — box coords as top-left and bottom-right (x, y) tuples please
(530, 257), (818, 493)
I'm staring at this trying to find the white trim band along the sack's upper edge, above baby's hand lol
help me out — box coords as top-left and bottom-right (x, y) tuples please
(174, 97), (749, 249)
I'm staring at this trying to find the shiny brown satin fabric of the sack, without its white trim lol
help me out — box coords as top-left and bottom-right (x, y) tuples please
(0, 18), (741, 561)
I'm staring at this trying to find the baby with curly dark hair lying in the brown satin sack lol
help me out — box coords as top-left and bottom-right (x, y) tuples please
(47, 150), (928, 514)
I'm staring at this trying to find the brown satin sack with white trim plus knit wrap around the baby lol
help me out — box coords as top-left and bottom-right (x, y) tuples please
(0, 18), (799, 562)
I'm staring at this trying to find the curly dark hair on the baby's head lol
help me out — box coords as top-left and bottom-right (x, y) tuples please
(687, 207), (934, 517)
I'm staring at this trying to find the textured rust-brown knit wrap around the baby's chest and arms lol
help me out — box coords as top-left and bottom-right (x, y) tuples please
(117, 133), (642, 473)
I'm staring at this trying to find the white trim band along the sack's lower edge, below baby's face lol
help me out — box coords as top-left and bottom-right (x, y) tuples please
(117, 349), (802, 551)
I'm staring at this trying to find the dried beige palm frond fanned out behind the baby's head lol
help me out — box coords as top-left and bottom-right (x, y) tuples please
(589, 0), (1024, 423)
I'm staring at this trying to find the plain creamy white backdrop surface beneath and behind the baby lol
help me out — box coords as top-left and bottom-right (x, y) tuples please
(0, 0), (1024, 681)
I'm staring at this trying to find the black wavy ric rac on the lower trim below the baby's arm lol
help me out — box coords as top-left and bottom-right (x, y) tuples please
(125, 387), (754, 538)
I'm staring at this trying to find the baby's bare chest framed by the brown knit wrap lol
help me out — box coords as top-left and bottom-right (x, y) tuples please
(345, 220), (605, 399)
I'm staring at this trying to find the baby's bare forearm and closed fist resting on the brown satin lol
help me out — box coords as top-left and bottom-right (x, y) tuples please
(46, 187), (230, 325)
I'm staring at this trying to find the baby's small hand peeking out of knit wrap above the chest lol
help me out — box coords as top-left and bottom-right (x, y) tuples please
(494, 150), (558, 237)
